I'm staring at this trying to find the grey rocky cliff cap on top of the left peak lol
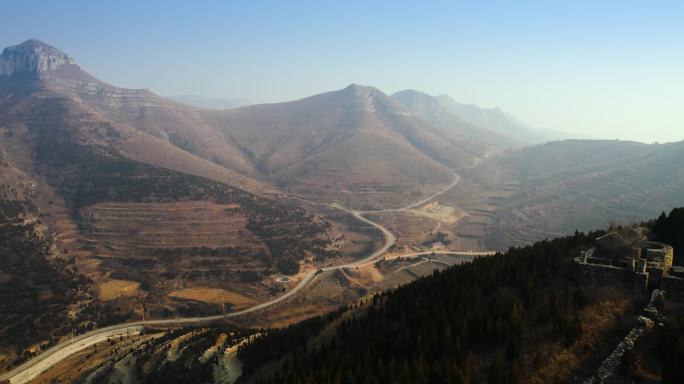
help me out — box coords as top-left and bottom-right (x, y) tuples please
(0, 40), (74, 76)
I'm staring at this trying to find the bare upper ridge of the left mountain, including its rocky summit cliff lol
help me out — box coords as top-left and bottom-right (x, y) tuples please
(0, 40), (266, 192)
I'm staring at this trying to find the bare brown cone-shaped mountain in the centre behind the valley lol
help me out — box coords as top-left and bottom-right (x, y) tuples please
(206, 85), (478, 207)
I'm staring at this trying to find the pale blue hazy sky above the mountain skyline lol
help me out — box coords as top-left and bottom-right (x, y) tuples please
(0, 0), (684, 142)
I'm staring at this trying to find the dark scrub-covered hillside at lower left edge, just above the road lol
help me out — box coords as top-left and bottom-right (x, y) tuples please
(0, 196), (125, 364)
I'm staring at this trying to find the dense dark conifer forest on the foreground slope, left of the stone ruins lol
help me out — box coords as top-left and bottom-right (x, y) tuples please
(239, 233), (631, 383)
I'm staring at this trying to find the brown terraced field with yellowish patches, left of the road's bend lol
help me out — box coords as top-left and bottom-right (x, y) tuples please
(71, 201), (332, 316)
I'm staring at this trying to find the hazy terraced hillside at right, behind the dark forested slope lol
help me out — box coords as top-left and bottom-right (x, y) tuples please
(448, 141), (684, 249)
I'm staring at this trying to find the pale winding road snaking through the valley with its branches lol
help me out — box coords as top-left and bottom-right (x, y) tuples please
(0, 164), (484, 384)
